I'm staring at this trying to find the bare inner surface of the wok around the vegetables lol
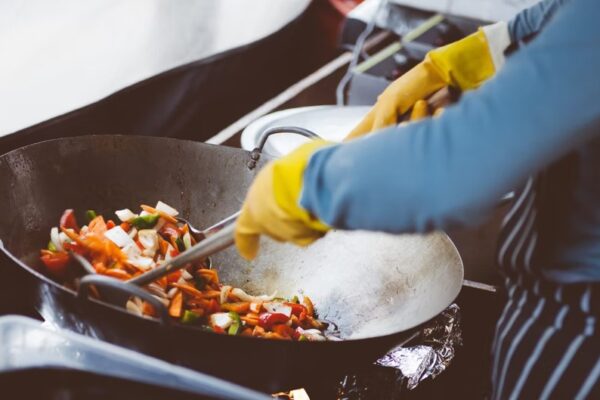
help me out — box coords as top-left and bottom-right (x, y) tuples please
(0, 136), (463, 338)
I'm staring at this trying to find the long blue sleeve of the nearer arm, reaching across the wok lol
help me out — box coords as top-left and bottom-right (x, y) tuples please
(300, 0), (600, 233)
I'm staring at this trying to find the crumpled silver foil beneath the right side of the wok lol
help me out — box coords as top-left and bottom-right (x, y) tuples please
(338, 304), (462, 400)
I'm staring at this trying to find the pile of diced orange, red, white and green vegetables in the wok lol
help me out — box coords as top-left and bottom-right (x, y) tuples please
(40, 201), (330, 341)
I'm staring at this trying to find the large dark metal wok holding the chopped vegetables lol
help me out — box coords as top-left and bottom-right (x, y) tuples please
(0, 136), (463, 392)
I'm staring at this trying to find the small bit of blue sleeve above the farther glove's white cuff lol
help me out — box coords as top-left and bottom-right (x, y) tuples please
(508, 0), (571, 43)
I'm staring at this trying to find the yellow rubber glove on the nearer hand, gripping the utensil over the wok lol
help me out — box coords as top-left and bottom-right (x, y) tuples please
(235, 140), (330, 260)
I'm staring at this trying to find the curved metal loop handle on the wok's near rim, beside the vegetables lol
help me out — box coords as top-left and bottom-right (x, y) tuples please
(77, 275), (171, 325)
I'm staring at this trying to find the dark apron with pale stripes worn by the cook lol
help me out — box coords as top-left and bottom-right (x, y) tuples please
(492, 177), (600, 399)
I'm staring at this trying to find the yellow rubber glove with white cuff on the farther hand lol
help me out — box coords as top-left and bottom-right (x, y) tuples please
(344, 22), (510, 140)
